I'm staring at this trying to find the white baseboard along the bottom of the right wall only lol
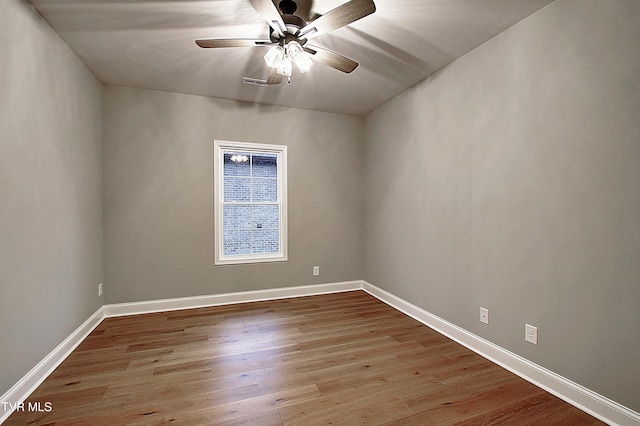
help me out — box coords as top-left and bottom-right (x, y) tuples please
(362, 281), (640, 426)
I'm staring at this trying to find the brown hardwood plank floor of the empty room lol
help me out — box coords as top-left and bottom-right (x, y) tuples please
(6, 291), (602, 425)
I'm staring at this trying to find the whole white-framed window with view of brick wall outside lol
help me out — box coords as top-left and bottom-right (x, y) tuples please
(213, 141), (287, 265)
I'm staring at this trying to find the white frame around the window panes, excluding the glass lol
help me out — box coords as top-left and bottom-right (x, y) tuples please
(213, 140), (287, 265)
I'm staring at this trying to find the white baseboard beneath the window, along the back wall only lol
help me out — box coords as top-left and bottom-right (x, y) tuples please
(104, 281), (362, 317)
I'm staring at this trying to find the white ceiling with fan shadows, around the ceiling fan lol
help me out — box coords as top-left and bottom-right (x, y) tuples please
(30, 0), (552, 115)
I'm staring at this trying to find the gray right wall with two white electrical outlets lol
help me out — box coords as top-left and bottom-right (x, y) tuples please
(364, 0), (640, 411)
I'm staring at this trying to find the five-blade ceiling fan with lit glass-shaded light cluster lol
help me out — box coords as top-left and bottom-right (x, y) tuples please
(196, 0), (376, 86)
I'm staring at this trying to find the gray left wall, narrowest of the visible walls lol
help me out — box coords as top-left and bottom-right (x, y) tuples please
(0, 0), (103, 395)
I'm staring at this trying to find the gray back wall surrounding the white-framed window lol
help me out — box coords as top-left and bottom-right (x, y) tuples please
(104, 86), (364, 303)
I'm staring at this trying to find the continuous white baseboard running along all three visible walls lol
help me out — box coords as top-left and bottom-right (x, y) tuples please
(0, 281), (640, 426)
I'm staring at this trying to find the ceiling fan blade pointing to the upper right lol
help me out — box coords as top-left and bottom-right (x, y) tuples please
(298, 0), (376, 39)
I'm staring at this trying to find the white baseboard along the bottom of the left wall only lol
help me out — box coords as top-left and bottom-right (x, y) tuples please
(0, 307), (104, 424)
